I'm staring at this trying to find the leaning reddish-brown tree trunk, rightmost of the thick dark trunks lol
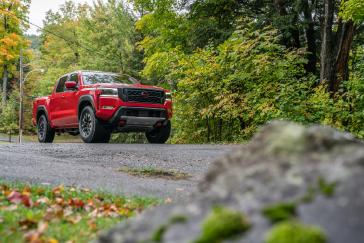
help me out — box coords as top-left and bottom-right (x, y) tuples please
(333, 21), (355, 92)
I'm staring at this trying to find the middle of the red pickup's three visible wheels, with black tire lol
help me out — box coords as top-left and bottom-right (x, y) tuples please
(78, 106), (111, 143)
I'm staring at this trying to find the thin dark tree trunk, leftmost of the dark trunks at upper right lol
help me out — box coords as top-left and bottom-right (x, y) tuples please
(302, 0), (317, 74)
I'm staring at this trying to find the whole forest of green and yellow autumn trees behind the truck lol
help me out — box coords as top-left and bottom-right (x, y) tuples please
(0, 0), (364, 143)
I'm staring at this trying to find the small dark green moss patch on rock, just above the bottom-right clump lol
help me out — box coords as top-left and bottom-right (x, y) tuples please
(262, 203), (296, 223)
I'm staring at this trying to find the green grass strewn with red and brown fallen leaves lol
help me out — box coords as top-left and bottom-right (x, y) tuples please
(0, 180), (160, 243)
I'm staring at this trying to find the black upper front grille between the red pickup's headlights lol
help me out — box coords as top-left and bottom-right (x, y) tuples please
(119, 88), (165, 104)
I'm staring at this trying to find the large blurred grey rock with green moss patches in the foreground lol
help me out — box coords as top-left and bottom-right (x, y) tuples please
(98, 121), (364, 243)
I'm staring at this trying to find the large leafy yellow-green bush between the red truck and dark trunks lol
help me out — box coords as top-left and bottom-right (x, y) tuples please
(169, 20), (321, 143)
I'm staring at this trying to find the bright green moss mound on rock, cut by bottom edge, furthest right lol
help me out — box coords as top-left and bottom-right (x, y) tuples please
(265, 222), (327, 243)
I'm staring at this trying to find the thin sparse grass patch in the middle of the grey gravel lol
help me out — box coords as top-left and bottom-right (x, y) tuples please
(118, 167), (191, 180)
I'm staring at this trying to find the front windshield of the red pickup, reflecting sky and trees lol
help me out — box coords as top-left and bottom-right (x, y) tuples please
(82, 72), (138, 85)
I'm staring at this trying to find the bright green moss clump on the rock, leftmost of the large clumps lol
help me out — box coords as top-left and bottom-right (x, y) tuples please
(195, 207), (250, 243)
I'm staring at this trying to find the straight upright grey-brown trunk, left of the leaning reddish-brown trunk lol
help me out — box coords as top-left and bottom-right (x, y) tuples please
(320, 0), (335, 91)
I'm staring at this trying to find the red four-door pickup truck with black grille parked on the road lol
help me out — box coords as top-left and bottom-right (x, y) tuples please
(32, 71), (172, 143)
